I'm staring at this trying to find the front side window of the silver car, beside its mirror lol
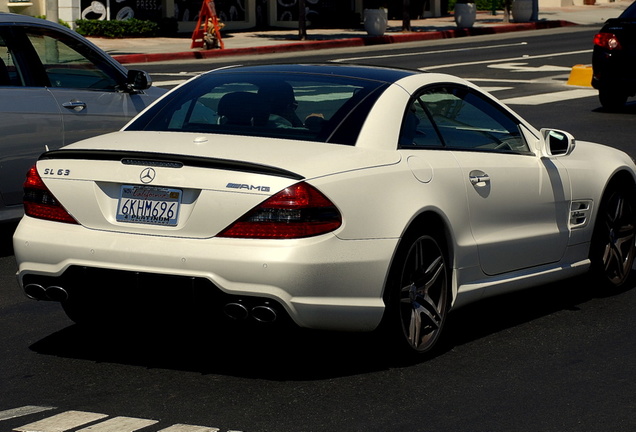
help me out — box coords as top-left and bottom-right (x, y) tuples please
(27, 32), (119, 90)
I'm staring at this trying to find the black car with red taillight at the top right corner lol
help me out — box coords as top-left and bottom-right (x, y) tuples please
(592, 2), (636, 110)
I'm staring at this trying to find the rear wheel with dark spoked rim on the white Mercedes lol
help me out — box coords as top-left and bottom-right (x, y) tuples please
(383, 235), (450, 358)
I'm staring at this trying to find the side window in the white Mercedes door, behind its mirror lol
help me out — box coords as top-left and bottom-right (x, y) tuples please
(418, 86), (530, 153)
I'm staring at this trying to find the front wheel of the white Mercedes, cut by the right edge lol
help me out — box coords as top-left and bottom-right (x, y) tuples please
(590, 183), (636, 289)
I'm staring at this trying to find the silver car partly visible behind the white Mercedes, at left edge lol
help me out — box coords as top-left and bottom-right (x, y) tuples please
(0, 13), (165, 222)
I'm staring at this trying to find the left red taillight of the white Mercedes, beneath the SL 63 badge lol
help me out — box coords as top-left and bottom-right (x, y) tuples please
(24, 165), (77, 224)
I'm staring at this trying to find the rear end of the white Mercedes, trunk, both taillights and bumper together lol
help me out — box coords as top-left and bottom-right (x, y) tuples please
(14, 132), (408, 330)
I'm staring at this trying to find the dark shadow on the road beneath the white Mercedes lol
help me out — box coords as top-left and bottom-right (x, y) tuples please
(31, 278), (616, 381)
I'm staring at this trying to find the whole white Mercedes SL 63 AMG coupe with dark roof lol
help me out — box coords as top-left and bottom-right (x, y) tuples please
(14, 61), (636, 355)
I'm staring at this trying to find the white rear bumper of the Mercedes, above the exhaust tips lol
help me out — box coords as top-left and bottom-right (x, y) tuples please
(14, 217), (398, 331)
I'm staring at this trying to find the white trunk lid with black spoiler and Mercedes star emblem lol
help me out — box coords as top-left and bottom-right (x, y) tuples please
(38, 132), (399, 238)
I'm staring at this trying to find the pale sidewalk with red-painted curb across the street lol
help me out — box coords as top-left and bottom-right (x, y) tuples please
(89, 1), (631, 63)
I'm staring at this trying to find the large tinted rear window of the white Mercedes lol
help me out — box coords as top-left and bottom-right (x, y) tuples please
(127, 72), (387, 145)
